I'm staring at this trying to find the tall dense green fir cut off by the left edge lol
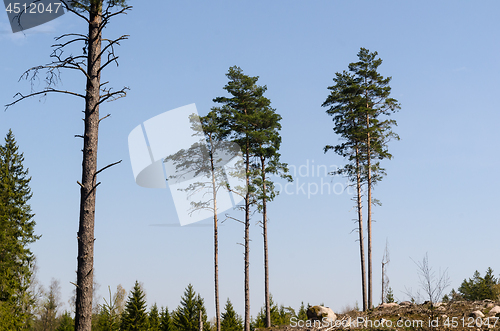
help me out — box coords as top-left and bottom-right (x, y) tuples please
(0, 130), (40, 329)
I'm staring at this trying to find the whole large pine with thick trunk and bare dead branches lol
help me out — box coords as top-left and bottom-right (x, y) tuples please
(6, 0), (132, 331)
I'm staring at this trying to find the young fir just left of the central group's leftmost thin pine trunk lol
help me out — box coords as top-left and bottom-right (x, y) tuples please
(172, 284), (210, 331)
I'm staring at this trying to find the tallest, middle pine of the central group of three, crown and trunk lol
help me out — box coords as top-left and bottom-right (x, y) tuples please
(213, 66), (270, 331)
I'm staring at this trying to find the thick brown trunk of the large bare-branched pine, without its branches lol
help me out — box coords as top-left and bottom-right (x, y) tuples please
(75, 1), (102, 331)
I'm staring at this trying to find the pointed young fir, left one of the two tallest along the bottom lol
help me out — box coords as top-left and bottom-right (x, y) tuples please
(120, 281), (149, 331)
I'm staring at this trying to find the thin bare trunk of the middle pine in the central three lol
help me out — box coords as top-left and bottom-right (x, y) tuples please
(244, 138), (250, 331)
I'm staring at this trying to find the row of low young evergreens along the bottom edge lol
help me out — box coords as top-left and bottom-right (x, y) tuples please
(26, 280), (307, 331)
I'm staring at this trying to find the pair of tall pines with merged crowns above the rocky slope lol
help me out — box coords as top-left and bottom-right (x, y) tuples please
(323, 48), (400, 309)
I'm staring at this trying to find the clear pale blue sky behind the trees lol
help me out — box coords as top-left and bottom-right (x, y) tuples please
(0, 0), (500, 316)
